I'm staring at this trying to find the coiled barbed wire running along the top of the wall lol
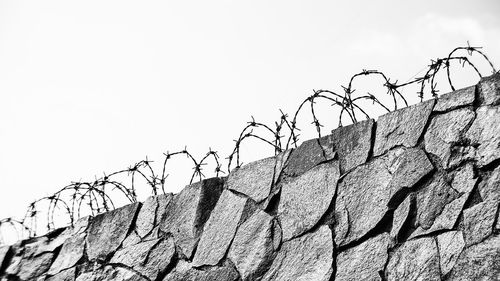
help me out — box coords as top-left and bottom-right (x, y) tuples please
(0, 42), (497, 244)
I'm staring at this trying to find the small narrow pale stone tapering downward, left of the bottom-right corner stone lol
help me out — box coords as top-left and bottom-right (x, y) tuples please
(436, 231), (465, 276)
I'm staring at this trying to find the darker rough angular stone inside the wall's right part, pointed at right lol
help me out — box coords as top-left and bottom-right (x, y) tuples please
(416, 173), (458, 229)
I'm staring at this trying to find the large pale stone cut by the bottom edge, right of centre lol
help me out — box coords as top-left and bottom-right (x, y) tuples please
(263, 226), (333, 281)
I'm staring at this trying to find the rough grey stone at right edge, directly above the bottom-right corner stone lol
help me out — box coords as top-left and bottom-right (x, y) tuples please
(459, 200), (498, 247)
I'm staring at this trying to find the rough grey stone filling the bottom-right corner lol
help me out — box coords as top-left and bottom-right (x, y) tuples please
(446, 235), (500, 281)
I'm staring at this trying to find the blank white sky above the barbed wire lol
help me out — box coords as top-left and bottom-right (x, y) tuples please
(0, 0), (500, 238)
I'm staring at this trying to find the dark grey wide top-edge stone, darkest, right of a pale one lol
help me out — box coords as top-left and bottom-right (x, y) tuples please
(284, 136), (335, 177)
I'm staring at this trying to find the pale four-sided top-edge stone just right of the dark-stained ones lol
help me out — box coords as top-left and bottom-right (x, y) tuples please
(373, 100), (435, 156)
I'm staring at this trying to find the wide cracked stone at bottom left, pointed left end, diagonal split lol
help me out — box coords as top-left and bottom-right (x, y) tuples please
(110, 235), (175, 280)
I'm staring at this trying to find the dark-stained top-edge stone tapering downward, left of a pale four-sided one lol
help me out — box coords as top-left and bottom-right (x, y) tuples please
(331, 119), (374, 174)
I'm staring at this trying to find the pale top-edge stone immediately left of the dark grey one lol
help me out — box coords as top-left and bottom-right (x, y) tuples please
(226, 154), (276, 202)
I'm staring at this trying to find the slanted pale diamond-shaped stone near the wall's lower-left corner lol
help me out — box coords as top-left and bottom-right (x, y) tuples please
(48, 233), (86, 275)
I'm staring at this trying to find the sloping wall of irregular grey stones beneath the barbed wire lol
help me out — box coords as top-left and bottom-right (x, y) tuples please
(0, 74), (500, 281)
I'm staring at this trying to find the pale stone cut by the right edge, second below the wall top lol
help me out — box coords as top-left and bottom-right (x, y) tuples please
(466, 106), (500, 167)
